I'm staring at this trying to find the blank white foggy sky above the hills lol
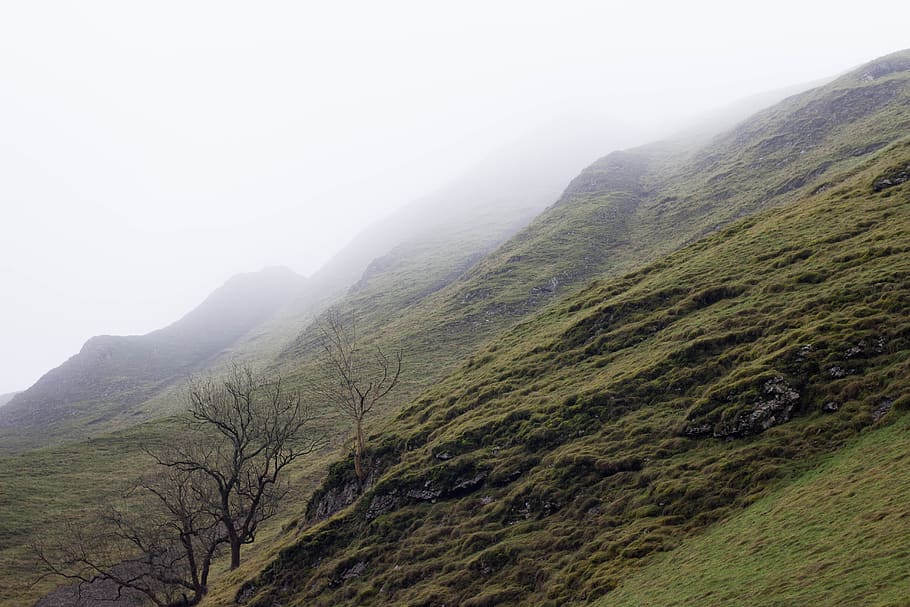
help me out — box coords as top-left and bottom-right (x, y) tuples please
(0, 0), (910, 393)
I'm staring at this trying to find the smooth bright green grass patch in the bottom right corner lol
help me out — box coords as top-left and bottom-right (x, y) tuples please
(598, 415), (910, 607)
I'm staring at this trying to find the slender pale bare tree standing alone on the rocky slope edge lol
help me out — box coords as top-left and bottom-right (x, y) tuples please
(315, 310), (402, 483)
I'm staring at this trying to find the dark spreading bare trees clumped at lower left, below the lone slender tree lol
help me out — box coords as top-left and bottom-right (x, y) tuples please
(35, 365), (318, 607)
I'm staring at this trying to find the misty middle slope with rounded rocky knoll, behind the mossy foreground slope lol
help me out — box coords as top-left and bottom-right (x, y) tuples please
(282, 51), (910, 422)
